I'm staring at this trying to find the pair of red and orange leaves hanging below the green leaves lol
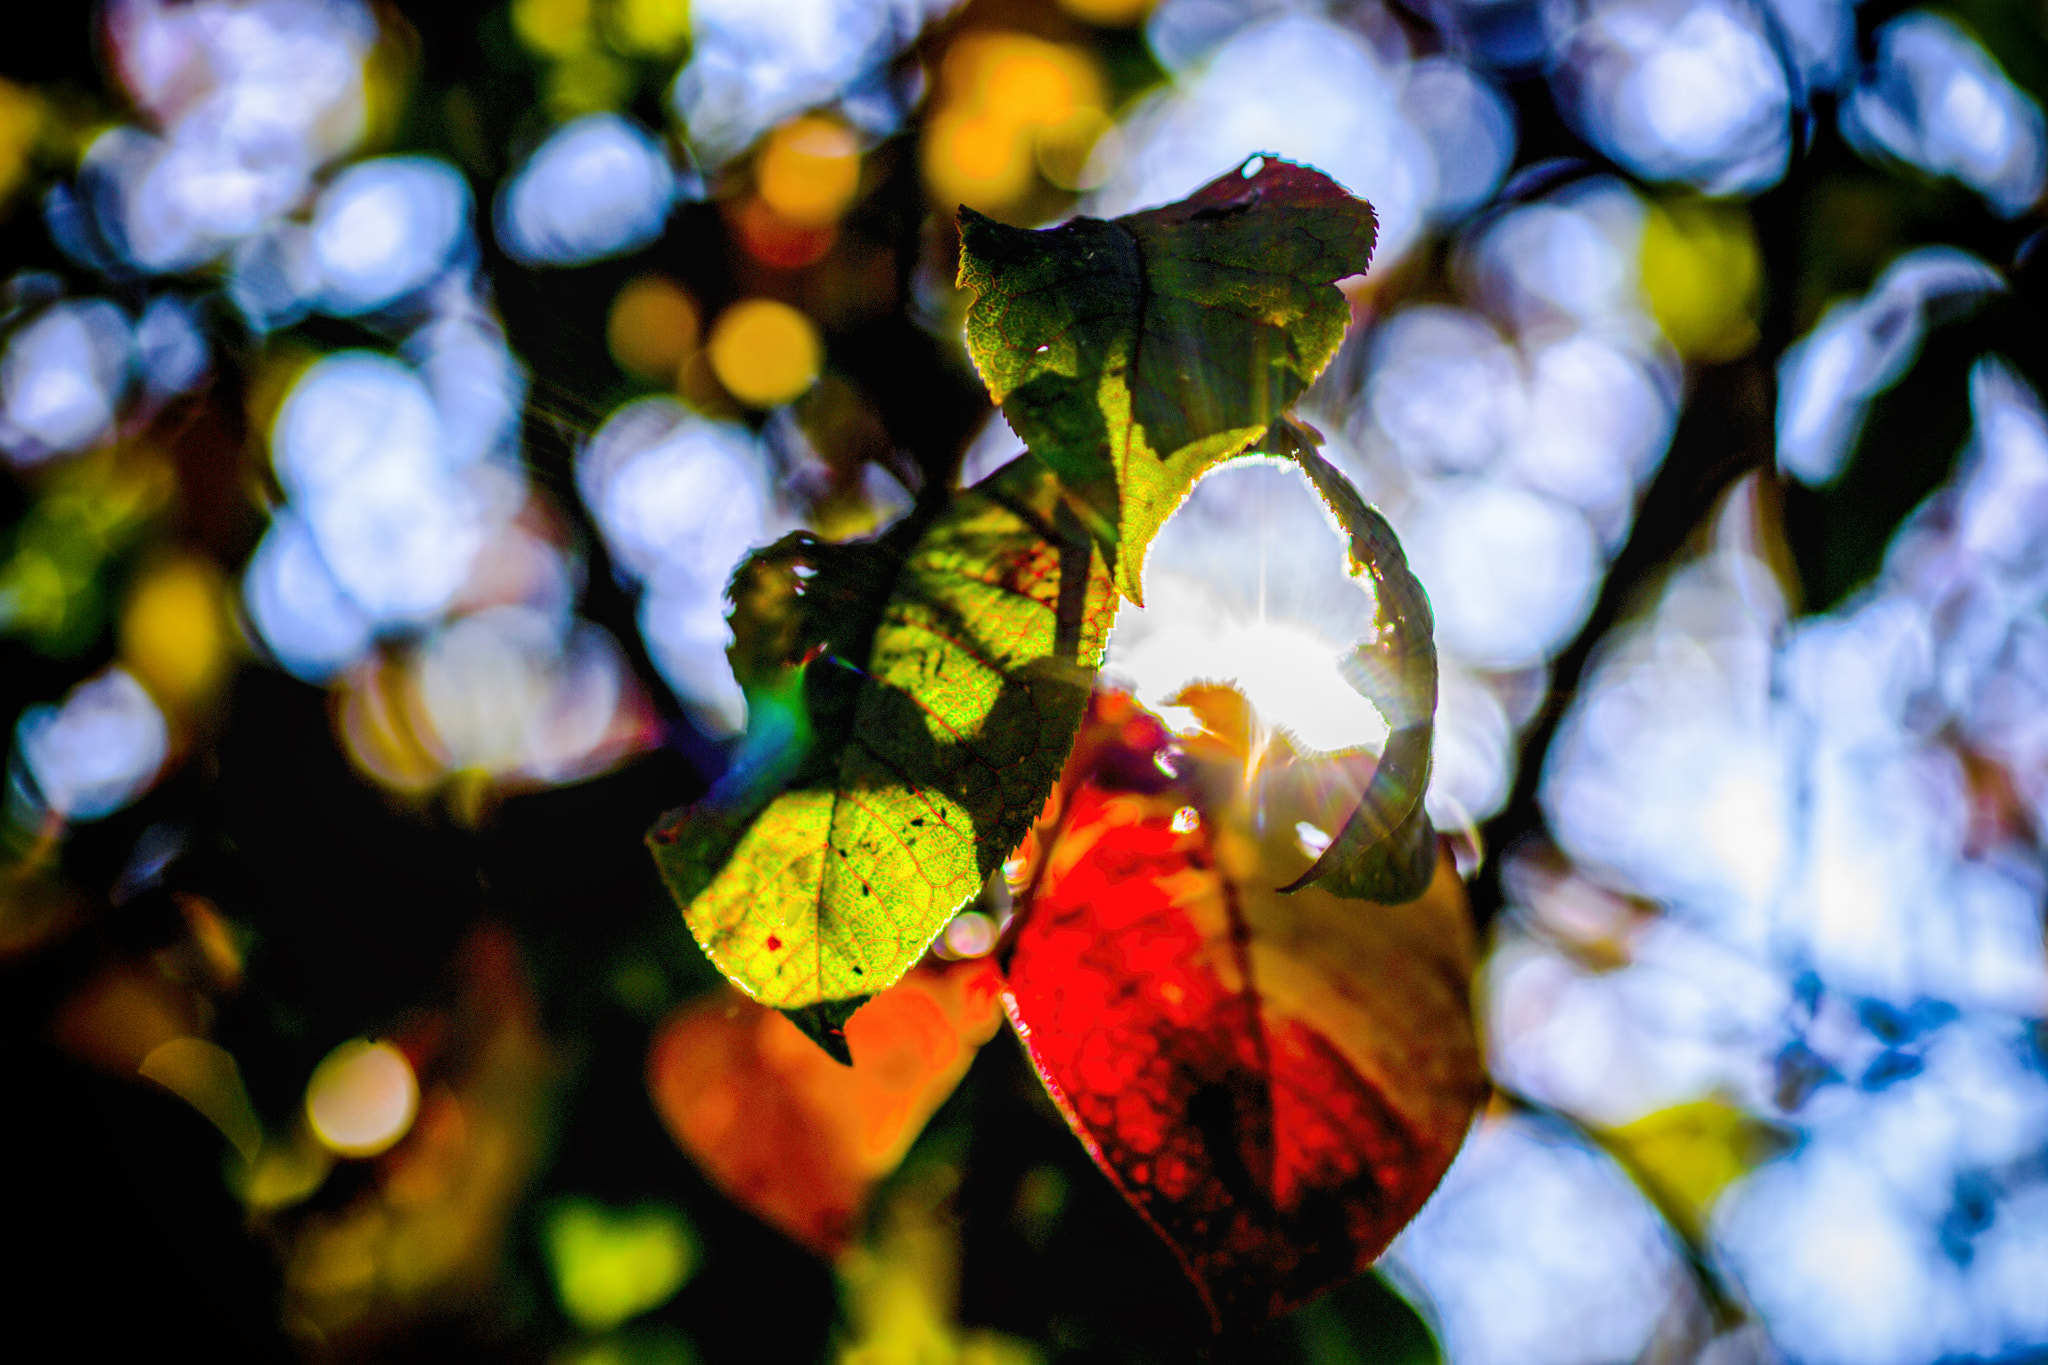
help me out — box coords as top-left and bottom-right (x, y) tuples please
(649, 690), (1485, 1330)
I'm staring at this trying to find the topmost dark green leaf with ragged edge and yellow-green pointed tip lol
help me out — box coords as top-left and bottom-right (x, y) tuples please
(961, 156), (1374, 602)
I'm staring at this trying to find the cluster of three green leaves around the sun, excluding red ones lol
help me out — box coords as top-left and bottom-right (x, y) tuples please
(649, 156), (1436, 1060)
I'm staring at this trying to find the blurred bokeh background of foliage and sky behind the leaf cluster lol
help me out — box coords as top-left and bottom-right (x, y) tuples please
(0, 0), (2048, 1365)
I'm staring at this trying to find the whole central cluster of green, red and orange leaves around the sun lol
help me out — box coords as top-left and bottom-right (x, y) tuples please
(649, 156), (1483, 1330)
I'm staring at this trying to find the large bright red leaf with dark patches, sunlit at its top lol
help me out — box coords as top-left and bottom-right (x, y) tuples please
(1006, 692), (1485, 1330)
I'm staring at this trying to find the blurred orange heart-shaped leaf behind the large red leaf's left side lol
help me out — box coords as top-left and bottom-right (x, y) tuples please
(647, 958), (1001, 1257)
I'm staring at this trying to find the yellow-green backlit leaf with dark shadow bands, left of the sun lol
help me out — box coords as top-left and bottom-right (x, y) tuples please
(649, 458), (1116, 1015)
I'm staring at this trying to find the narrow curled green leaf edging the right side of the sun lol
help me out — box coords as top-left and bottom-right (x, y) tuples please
(1262, 417), (1436, 905)
